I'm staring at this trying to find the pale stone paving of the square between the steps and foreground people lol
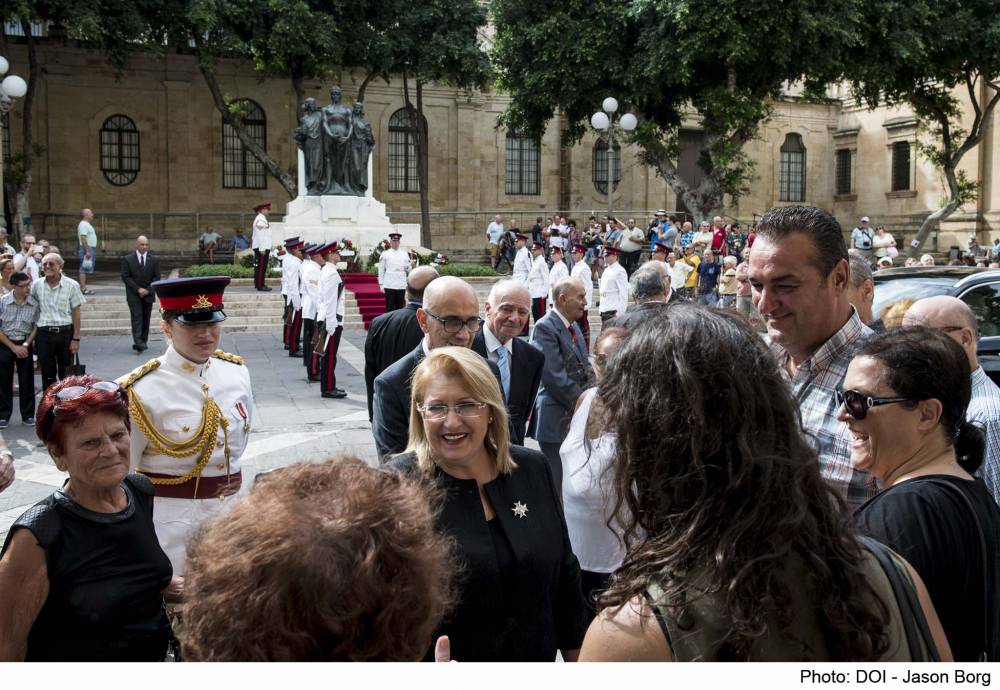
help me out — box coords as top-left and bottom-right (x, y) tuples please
(0, 329), (376, 540)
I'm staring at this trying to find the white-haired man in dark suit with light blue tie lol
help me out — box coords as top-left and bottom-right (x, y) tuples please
(472, 280), (545, 446)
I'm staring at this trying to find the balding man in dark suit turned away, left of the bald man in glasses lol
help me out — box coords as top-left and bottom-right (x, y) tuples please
(365, 266), (438, 422)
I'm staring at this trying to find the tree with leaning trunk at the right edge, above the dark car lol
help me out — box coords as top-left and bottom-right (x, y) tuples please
(845, 0), (1000, 256)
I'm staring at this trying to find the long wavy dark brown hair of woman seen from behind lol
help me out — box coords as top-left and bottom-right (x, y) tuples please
(598, 304), (889, 661)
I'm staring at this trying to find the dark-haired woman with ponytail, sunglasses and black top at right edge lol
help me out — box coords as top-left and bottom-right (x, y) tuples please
(838, 327), (1000, 661)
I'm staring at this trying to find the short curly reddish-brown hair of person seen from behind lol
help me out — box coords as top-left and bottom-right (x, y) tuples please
(181, 458), (455, 661)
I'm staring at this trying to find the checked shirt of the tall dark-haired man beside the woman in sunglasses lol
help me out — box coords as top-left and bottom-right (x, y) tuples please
(771, 307), (876, 510)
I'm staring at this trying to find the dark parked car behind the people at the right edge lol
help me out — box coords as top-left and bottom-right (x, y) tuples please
(872, 266), (1000, 385)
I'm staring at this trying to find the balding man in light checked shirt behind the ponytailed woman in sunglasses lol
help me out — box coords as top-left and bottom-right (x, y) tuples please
(903, 295), (1000, 501)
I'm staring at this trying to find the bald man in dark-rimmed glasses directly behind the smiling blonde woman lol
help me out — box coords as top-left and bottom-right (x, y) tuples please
(372, 276), (500, 462)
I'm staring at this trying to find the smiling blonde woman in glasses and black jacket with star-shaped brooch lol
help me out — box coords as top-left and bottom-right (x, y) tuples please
(392, 347), (588, 661)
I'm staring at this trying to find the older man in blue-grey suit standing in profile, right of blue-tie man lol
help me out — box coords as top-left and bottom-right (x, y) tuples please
(528, 278), (593, 487)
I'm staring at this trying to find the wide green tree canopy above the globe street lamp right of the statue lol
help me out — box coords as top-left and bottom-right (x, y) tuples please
(492, 0), (862, 219)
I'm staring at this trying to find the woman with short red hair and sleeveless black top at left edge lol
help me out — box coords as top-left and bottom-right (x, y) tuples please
(0, 376), (172, 661)
